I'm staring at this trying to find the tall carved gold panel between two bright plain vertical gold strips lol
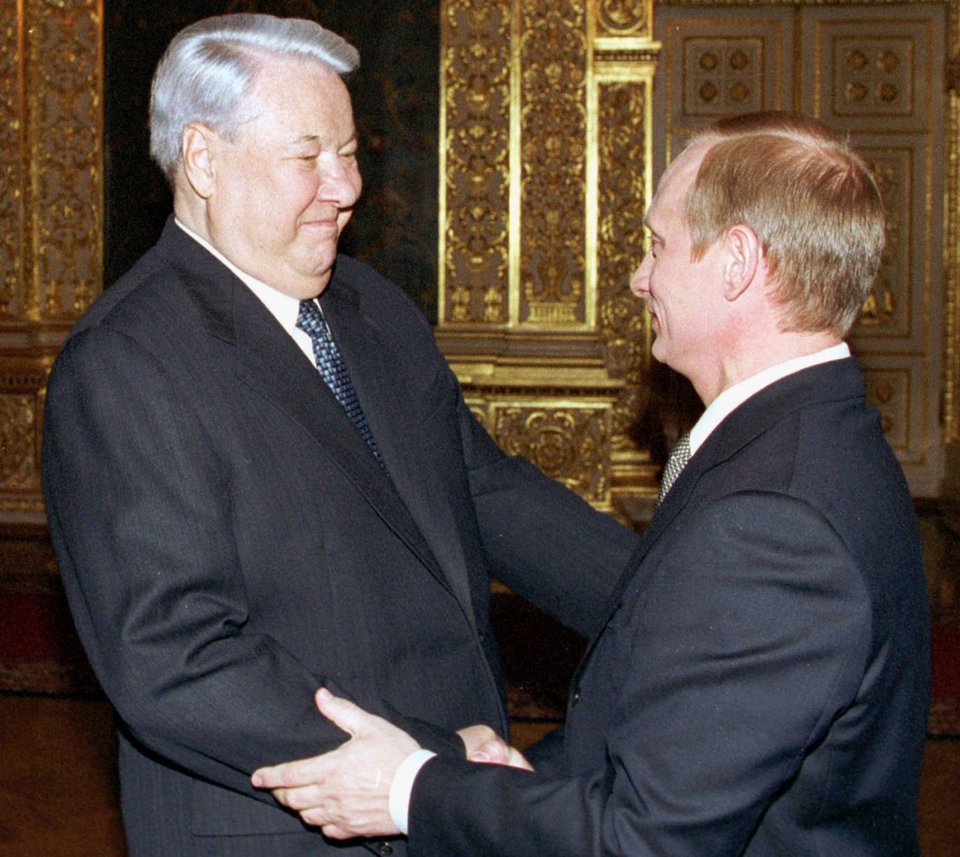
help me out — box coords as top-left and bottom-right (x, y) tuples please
(520, 0), (587, 327)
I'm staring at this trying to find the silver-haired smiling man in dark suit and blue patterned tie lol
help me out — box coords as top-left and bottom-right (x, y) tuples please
(43, 15), (636, 857)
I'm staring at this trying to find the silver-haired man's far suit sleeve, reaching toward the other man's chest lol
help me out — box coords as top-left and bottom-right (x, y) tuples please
(460, 386), (639, 637)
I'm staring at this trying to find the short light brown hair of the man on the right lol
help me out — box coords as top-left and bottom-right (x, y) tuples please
(686, 112), (884, 337)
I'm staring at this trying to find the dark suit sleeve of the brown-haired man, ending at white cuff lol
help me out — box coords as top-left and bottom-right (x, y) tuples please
(410, 495), (870, 857)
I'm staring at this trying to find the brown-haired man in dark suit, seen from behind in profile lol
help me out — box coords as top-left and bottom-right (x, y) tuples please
(254, 114), (929, 857)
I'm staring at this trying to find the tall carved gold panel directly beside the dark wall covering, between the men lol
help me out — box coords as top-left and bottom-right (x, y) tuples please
(440, 0), (511, 326)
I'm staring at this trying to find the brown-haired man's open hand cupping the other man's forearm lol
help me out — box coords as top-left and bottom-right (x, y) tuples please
(251, 688), (419, 839)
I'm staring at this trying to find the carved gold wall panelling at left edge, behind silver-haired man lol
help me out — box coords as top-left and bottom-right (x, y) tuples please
(0, 0), (103, 526)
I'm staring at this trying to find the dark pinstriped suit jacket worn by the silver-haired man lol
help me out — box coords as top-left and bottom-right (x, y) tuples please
(43, 220), (636, 857)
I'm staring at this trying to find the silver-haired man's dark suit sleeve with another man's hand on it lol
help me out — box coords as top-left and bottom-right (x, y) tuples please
(43, 327), (462, 804)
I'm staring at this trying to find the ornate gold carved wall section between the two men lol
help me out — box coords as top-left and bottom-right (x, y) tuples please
(437, 0), (659, 519)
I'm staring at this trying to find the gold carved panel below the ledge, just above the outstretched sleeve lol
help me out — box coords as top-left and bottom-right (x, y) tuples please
(493, 405), (610, 504)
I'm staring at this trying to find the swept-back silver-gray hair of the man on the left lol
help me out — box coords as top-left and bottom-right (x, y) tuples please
(150, 14), (360, 183)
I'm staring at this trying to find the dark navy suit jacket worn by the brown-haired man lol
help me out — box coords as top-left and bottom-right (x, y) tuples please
(410, 359), (929, 857)
